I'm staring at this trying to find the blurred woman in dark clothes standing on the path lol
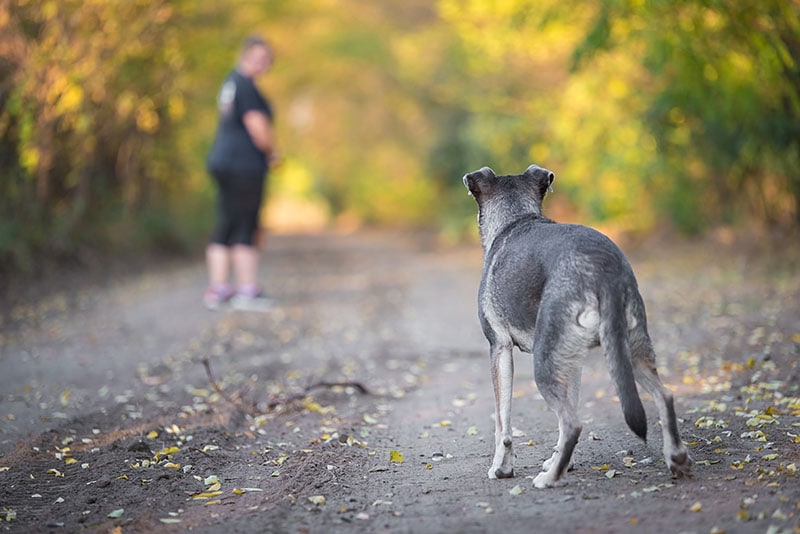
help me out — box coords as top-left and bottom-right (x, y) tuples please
(203, 36), (274, 310)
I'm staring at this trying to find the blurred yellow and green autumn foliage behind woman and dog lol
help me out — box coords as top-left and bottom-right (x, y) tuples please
(0, 0), (800, 273)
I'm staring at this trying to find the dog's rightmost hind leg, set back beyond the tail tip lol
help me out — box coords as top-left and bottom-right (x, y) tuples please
(631, 338), (692, 478)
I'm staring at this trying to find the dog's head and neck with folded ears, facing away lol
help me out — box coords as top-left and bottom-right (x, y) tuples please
(464, 165), (555, 245)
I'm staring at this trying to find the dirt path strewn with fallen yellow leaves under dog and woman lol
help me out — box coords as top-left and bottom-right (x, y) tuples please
(0, 234), (800, 533)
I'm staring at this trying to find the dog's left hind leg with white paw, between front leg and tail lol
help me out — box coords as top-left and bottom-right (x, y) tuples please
(533, 325), (583, 488)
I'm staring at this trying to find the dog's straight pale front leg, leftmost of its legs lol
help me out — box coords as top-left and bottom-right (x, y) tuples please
(489, 344), (514, 478)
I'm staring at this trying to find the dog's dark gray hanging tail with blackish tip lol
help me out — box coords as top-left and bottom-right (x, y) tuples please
(599, 290), (647, 441)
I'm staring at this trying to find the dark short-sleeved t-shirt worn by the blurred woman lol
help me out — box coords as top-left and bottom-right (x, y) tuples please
(207, 70), (272, 175)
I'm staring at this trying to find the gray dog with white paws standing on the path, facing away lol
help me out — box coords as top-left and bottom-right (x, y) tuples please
(464, 165), (692, 488)
